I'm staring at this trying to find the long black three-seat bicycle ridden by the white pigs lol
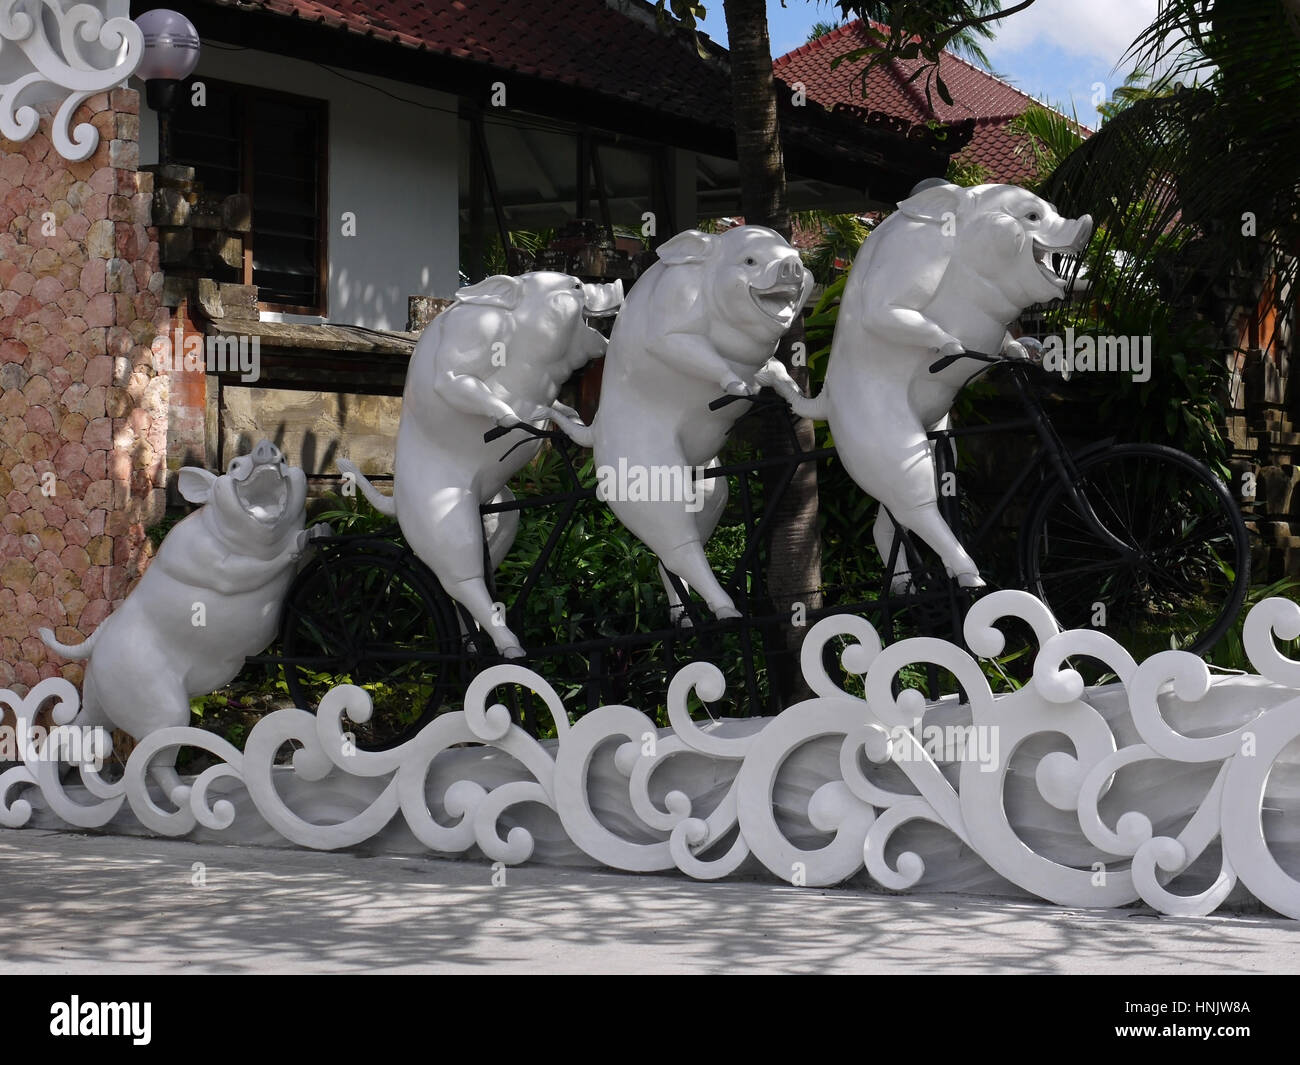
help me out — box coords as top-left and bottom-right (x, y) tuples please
(261, 351), (1249, 749)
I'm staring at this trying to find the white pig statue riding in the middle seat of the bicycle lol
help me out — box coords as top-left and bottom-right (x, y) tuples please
(556, 225), (813, 620)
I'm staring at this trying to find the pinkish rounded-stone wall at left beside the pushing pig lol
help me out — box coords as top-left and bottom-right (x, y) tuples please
(0, 88), (168, 692)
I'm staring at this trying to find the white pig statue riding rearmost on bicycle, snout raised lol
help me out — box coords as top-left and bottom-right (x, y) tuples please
(338, 270), (623, 658)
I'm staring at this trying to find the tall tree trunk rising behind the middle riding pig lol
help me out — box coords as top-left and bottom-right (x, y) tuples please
(725, 0), (822, 706)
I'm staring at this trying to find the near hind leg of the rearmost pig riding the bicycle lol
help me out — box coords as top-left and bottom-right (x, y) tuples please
(398, 492), (524, 658)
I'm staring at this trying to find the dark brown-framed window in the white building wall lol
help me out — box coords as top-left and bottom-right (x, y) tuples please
(168, 78), (328, 315)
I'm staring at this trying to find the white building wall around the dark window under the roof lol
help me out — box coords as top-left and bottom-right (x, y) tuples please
(133, 46), (460, 329)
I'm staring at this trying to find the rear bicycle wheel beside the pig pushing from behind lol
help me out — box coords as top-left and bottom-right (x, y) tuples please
(281, 540), (462, 750)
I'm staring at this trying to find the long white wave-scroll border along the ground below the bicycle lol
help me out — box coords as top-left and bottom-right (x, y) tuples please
(0, 592), (1300, 918)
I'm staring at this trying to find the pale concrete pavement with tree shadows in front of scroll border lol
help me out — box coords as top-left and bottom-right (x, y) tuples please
(0, 830), (1300, 974)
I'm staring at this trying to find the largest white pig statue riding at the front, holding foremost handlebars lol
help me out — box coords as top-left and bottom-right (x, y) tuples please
(761, 182), (1092, 590)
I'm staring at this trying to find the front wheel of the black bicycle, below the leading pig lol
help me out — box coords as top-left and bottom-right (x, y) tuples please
(1023, 443), (1251, 662)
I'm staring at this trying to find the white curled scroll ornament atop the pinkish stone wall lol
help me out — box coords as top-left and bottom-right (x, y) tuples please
(0, 0), (144, 163)
